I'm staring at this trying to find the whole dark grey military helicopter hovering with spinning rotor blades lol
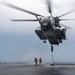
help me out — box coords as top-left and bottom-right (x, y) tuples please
(2, 0), (75, 50)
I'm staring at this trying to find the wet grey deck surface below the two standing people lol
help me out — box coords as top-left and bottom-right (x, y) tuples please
(0, 64), (75, 75)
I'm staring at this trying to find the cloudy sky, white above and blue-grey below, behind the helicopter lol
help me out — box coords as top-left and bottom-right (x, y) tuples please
(0, 0), (75, 63)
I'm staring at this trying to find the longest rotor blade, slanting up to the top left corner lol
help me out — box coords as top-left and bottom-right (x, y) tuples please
(2, 2), (44, 17)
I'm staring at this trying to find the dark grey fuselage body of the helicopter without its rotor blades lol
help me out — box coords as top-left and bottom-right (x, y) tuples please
(35, 17), (66, 45)
